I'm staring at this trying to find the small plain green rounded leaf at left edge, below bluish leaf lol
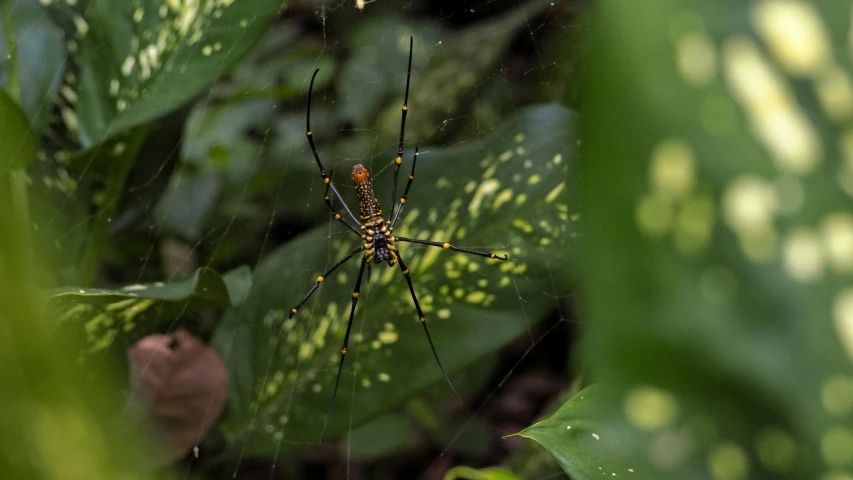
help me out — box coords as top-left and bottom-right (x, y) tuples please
(0, 90), (36, 173)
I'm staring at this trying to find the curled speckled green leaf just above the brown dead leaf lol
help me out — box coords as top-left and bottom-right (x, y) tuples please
(46, 267), (252, 353)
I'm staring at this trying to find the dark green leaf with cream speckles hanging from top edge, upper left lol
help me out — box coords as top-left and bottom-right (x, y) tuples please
(41, 0), (284, 147)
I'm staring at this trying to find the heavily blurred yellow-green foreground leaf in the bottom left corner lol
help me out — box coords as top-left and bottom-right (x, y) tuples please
(0, 158), (155, 480)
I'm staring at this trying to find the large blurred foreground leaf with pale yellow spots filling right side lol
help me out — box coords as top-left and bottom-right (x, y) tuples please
(578, 0), (853, 479)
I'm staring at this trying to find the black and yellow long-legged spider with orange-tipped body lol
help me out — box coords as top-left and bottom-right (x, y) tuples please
(288, 37), (509, 442)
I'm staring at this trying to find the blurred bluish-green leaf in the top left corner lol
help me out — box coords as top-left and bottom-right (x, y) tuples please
(0, 0), (66, 134)
